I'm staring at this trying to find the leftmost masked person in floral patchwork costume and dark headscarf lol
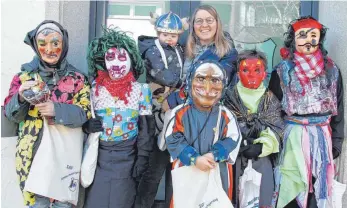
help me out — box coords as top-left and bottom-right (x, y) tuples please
(4, 20), (91, 208)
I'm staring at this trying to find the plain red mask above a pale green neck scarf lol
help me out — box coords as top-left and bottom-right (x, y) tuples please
(238, 58), (266, 89)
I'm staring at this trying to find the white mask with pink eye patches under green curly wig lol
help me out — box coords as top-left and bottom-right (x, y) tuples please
(105, 48), (131, 80)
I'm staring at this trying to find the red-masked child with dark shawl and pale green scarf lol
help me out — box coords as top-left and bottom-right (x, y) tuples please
(224, 50), (284, 208)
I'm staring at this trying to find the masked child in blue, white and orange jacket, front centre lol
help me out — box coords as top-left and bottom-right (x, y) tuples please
(165, 60), (242, 206)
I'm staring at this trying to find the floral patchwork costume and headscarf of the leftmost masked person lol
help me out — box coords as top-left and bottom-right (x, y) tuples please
(4, 20), (91, 207)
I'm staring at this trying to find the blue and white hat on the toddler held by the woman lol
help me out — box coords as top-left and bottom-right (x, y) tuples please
(155, 11), (184, 34)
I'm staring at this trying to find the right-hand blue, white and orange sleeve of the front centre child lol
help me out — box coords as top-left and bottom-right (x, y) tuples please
(212, 108), (242, 164)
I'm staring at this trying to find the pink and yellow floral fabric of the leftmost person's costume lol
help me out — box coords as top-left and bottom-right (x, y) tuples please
(4, 71), (91, 206)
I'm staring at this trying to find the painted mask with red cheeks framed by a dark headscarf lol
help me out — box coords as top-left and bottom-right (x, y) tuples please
(36, 32), (63, 64)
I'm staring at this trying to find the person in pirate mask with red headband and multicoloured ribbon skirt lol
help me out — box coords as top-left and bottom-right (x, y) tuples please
(269, 17), (344, 208)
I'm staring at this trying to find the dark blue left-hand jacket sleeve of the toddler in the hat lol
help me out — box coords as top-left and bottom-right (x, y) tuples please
(146, 48), (181, 88)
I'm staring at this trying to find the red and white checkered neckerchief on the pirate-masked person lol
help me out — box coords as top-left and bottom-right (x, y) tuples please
(293, 49), (324, 89)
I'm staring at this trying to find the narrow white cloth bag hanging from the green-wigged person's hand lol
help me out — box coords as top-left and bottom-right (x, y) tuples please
(81, 97), (102, 188)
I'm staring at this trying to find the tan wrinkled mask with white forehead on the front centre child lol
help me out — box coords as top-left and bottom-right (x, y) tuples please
(192, 64), (224, 111)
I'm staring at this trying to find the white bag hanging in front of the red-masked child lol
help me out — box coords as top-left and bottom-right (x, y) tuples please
(239, 160), (261, 208)
